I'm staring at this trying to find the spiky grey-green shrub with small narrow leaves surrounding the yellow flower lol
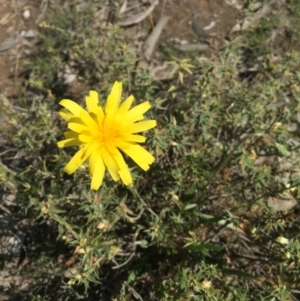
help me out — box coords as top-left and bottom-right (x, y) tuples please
(1, 1), (300, 301)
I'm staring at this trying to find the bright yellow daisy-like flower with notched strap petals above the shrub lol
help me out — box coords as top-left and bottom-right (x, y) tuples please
(57, 82), (156, 190)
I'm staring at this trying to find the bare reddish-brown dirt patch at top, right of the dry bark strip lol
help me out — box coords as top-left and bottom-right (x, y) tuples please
(154, 0), (243, 45)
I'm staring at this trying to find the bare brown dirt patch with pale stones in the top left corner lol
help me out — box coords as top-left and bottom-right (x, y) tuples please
(0, 0), (44, 96)
